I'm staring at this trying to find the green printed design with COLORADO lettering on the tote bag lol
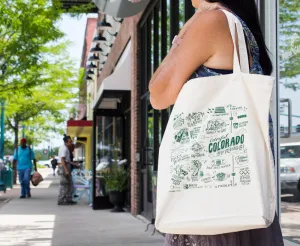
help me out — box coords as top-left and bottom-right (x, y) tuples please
(170, 105), (251, 192)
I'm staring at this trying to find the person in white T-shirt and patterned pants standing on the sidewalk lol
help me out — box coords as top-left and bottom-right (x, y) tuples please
(57, 135), (76, 205)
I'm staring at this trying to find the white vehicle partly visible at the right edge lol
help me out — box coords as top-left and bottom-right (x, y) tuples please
(280, 142), (300, 201)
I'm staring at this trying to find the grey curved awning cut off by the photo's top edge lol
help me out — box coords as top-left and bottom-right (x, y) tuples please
(93, 0), (150, 18)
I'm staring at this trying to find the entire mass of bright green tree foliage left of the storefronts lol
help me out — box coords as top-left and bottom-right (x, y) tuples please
(0, 0), (94, 144)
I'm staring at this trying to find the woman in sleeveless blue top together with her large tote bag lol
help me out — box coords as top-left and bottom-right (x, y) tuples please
(149, 0), (283, 246)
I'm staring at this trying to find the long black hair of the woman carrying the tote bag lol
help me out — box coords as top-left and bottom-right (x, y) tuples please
(206, 0), (273, 75)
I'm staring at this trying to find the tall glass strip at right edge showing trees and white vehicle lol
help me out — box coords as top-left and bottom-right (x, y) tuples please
(279, 0), (300, 245)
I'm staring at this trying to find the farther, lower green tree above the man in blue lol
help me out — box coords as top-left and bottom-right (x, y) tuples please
(6, 55), (78, 144)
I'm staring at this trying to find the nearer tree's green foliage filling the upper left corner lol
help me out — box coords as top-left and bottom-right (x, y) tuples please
(0, 0), (64, 94)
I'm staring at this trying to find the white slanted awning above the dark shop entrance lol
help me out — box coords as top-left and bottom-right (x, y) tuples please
(93, 41), (131, 109)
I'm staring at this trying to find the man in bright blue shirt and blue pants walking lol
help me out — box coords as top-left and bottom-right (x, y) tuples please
(14, 138), (37, 199)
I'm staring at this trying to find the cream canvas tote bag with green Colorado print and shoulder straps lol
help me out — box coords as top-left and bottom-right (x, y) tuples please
(155, 10), (275, 235)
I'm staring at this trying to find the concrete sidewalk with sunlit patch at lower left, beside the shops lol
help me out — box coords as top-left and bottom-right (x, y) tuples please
(0, 169), (164, 246)
